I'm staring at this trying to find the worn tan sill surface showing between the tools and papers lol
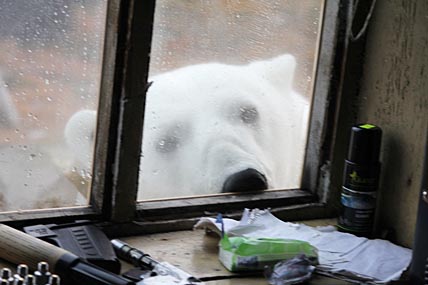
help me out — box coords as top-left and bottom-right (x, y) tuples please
(121, 219), (352, 285)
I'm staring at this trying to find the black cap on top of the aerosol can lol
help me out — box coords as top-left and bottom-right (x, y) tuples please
(347, 124), (382, 164)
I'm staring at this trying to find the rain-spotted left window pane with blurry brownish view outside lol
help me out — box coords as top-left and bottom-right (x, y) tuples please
(0, 0), (106, 211)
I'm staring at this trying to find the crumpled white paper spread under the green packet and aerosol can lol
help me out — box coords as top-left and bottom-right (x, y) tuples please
(195, 209), (412, 284)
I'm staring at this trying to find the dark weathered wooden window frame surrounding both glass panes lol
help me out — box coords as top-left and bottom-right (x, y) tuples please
(0, 0), (351, 234)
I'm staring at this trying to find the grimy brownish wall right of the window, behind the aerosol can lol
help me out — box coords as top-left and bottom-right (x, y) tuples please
(354, 0), (428, 247)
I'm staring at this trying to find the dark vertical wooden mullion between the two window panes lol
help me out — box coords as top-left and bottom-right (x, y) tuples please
(104, 0), (155, 222)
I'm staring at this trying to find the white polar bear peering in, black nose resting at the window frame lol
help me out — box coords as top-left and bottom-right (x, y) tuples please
(66, 54), (309, 199)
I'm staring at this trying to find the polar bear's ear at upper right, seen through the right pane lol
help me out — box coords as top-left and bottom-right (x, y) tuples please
(249, 54), (296, 90)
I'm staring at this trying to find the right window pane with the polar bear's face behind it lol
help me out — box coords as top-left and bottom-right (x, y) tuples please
(138, 0), (324, 200)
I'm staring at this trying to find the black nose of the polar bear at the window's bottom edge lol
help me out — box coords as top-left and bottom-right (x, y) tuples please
(222, 168), (268, 193)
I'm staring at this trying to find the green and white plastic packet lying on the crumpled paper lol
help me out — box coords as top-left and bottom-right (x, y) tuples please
(219, 235), (318, 272)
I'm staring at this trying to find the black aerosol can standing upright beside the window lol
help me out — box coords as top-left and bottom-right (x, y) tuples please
(338, 124), (382, 237)
